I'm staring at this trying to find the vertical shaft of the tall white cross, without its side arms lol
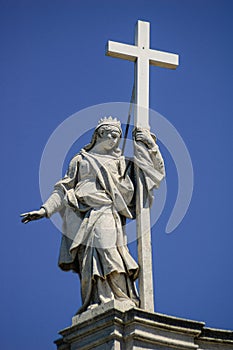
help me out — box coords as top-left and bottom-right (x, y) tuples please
(134, 21), (154, 312)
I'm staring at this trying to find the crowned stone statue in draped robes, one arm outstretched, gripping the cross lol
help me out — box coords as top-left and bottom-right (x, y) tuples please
(21, 117), (165, 313)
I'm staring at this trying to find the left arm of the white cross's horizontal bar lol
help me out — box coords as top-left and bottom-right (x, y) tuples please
(106, 41), (138, 62)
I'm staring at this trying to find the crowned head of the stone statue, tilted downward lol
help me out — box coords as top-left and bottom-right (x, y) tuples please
(85, 117), (122, 154)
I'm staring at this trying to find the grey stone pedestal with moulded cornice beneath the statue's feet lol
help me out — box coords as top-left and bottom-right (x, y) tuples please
(55, 301), (233, 350)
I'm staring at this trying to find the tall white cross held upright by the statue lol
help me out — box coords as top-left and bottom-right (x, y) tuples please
(106, 21), (179, 312)
